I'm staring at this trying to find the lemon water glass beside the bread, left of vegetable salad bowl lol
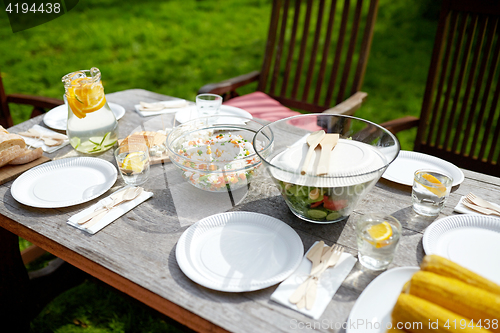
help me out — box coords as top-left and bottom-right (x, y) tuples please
(115, 143), (149, 186)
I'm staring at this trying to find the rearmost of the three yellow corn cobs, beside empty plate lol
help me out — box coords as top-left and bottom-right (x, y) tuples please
(420, 254), (500, 295)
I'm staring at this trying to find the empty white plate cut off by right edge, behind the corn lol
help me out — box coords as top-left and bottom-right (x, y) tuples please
(422, 214), (500, 284)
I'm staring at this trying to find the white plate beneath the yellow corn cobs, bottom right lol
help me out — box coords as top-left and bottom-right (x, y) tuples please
(347, 267), (419, 333)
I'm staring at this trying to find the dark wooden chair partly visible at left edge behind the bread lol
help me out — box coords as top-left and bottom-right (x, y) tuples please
(0, 73), (64, 128)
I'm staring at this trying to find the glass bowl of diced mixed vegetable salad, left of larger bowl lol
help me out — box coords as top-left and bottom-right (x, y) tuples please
(166, 115), (273, 192)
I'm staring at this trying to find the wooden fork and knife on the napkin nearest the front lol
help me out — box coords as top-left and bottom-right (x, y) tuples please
(289, 241), (344, 310)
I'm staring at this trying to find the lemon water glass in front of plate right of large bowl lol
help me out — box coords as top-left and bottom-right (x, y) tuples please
(411, 169), (453, 216)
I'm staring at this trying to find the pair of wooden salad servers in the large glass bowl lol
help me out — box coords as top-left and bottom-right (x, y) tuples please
(300, 130), (339, 176)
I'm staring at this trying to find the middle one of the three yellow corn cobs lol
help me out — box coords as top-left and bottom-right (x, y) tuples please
(410, 271), (500, 332)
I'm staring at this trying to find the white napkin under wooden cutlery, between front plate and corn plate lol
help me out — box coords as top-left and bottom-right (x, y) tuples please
(271, 242), (358, 319)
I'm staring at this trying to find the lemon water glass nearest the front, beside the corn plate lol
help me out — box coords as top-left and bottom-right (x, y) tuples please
(356, 214), (401, 271)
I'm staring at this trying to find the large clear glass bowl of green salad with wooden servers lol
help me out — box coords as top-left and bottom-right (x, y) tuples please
(254, 114), (400, 223)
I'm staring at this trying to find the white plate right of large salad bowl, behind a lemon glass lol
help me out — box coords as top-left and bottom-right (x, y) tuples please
(382, 150), (464, 186)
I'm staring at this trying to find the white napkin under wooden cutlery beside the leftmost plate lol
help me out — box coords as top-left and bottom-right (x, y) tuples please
(66, 186), (153, 234)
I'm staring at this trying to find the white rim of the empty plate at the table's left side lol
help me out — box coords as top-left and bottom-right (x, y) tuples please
(10, 157), (118, 208)
